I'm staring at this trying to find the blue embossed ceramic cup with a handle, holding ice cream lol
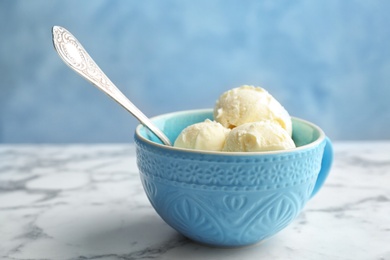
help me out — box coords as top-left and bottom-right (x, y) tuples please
(135, 109), (333, 247)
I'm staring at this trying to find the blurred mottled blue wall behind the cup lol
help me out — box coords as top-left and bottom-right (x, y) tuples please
(0, 0), (390, 143)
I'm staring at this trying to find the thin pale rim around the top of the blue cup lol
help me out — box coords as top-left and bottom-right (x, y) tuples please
(134, 108), (326, 156)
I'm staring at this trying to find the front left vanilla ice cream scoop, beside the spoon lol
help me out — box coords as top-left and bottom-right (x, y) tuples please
(174, 119), (230, 151)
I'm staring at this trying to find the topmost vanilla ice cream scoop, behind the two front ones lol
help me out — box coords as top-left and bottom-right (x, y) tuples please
(214, 85), (292, 136)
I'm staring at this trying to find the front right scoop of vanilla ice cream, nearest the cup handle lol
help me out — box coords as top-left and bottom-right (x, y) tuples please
(223, 120), (295, 152)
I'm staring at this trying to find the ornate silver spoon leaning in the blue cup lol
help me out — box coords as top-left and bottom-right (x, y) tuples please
(52, 26), (172, 146)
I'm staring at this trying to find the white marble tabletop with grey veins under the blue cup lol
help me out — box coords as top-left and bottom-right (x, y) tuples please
(0, 141), (390, 260)
